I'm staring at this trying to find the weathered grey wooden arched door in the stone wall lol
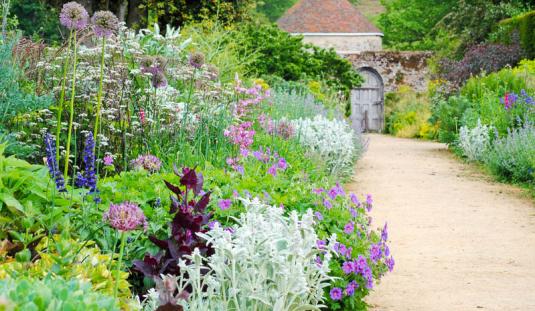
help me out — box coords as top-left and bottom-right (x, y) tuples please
(351, 67), (384, 132)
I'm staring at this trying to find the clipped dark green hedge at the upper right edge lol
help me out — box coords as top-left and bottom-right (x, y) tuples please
(497, 11), (535, 58)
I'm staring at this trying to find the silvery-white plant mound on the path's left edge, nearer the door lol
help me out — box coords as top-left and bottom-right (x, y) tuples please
(292, 115), (363, 175)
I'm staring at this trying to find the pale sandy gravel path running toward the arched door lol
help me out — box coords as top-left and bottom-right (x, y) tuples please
(347, 135), (535, 311)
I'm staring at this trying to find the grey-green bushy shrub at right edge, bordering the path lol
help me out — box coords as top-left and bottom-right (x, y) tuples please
(484, 122), (535, 182)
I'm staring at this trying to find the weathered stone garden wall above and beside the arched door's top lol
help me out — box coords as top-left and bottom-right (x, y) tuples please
(341, 51), (432, 92)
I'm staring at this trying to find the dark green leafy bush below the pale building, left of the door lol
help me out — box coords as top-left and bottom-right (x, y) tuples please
(235, 23), (362, 92)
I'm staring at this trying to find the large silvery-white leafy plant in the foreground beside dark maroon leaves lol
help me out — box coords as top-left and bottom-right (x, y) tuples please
(145, 199), (336, 311)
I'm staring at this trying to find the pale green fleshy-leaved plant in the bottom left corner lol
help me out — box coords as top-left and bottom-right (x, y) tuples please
(0, 278), (119, 311)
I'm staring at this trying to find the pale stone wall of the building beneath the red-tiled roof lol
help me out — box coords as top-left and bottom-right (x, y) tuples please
(303, 34), (383, 54)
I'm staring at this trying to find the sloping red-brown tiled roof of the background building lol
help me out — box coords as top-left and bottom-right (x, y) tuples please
(277, 0), (382, 34)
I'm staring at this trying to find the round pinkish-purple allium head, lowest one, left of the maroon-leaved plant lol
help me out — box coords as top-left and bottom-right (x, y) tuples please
(103, 202), (148, 232)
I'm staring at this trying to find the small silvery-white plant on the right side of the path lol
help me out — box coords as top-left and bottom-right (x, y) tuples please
(459, 120), (491, 161)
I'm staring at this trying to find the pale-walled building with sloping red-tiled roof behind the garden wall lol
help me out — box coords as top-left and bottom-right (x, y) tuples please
(277, 0), (383, 54)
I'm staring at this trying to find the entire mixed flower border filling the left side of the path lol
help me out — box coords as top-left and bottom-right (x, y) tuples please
(0, 2), (394, 310)
